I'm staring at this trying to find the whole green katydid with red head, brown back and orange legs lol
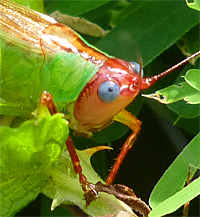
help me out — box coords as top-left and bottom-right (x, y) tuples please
(0, 0), (200, 203)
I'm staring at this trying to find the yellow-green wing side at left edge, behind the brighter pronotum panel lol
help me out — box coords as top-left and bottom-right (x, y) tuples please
(0, 37), (44, 116)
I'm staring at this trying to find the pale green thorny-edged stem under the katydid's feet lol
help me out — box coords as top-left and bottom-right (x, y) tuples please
(42, 147), (136, 216)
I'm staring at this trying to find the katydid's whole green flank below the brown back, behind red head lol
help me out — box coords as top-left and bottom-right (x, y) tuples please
(0, 37), (99, 115)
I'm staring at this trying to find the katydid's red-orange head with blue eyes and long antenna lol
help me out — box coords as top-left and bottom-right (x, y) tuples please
(74, 51), (200, 131)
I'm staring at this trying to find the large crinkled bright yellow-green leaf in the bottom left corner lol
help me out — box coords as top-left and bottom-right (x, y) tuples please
(0, 114), (68, 216)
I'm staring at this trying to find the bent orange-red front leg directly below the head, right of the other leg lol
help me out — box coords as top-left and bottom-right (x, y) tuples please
(106, 110), (141, 185)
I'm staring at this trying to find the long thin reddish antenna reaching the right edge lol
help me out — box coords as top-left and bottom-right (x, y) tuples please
(141, 50), (200, 90)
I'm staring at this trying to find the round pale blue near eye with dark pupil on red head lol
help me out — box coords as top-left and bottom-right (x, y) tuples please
(98, 81), (120, 103)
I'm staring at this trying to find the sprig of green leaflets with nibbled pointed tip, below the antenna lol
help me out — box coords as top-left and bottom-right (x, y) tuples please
(143, 69), (200, 118)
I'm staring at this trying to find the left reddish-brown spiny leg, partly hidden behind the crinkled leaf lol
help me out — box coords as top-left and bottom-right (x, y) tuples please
(40, 91), (98, 205)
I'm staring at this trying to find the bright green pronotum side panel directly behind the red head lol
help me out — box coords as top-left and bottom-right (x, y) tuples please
(41, 52), (100, 108)
